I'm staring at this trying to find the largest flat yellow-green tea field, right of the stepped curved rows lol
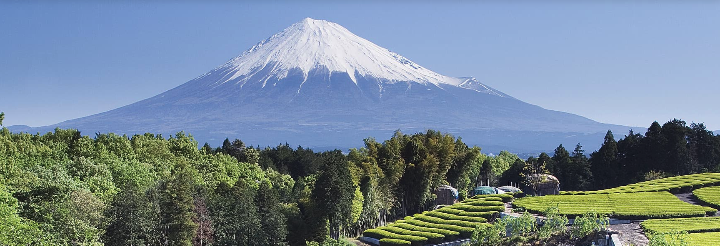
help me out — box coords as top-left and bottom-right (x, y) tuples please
(514, 191), (717, 219)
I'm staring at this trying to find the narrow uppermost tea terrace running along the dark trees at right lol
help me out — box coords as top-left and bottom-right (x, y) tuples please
(560, 173), (720, 195)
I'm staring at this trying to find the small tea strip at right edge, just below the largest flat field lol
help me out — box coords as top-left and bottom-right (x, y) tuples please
(640, 217), (720, 233)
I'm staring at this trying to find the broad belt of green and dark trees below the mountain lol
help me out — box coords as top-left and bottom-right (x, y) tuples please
(0, 114), (720, 245)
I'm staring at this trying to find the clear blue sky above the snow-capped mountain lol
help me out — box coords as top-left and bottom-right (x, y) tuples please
(0, 1), (720, 133)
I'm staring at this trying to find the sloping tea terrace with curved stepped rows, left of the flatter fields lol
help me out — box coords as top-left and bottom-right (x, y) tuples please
(363, 195), (512, 246)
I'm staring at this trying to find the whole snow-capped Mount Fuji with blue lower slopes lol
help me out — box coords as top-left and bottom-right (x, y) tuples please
(19, 18), (630, 152)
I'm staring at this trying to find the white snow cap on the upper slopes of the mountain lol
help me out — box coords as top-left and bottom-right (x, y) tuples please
(219, 18), (464, 87)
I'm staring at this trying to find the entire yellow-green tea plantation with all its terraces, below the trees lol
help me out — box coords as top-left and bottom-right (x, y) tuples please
(363, 173), (720, 246)
